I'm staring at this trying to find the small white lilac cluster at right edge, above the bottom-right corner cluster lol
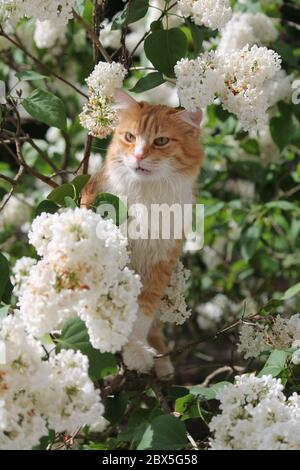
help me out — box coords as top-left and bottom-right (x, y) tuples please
(238, 314), (300, 362)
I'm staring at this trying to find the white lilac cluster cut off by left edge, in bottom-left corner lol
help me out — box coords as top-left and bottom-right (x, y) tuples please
(0, 316), (48, 450)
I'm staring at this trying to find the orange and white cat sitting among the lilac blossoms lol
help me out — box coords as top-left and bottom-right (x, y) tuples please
(81, 91), (203, 378)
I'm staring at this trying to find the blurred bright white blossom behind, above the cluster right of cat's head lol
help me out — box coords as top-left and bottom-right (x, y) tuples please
(217, 12), (278, 54)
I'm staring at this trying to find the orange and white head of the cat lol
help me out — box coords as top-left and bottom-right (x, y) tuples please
(108, 91), (202, 181)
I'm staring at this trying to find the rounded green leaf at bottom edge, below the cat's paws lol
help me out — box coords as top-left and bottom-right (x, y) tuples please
(137, 415), (187, 450)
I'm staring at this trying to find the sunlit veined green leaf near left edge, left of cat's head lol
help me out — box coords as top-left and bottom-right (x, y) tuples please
(22, 89), (67, 129)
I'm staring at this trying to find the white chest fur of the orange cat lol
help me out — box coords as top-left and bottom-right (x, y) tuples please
(105, 170), (194, 277)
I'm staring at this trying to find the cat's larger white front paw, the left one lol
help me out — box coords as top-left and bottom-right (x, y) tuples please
(123, 340), (156, 373)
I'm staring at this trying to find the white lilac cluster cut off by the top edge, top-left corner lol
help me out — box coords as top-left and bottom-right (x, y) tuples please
(0, 0), (76, 26)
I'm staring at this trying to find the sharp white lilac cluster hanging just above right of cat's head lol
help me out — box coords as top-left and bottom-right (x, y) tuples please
(175, 45), (281, 131)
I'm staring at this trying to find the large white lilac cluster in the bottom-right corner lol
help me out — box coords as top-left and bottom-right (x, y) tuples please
(209, 375), (300, 450)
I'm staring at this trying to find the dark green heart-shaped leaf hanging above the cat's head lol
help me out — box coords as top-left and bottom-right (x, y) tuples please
(144, 28), (188, 77)
